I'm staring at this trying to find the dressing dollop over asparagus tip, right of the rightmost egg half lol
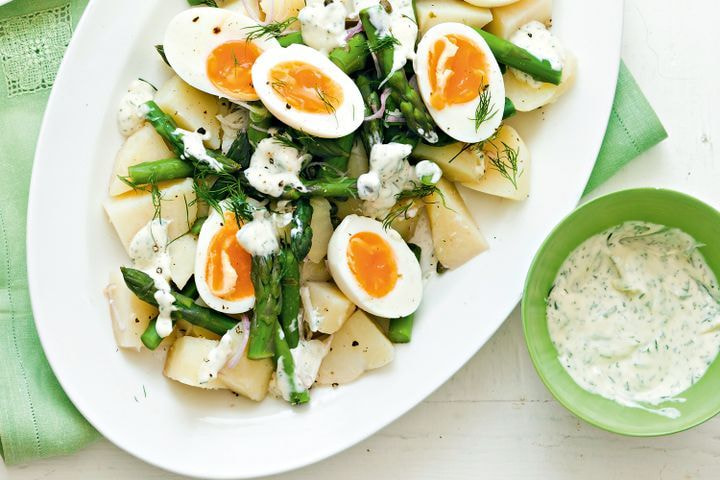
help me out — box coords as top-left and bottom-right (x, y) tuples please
(509, 20), (565, 88)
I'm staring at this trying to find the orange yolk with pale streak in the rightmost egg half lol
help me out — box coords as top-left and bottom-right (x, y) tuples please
(428, 35), (488, 110)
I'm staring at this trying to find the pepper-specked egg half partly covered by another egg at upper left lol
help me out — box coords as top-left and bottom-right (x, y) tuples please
(163, 7), (280, 101)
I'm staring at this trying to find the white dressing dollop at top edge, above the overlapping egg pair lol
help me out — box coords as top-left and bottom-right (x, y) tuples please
(298, 0), (347, 54)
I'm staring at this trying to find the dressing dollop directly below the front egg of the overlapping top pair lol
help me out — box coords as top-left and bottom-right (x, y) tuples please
(245, 137), (308, 197)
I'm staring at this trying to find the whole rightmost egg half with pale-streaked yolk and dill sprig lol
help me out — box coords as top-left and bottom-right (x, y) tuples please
(414, 22), (505, 143)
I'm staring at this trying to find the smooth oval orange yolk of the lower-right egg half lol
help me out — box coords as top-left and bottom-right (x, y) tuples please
(347, 232), (398, 298)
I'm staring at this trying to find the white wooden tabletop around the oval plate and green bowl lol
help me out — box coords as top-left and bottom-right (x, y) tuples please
(5, 0), (720, 480)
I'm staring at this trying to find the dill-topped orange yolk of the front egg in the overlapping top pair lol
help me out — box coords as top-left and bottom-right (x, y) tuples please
(269, 61), (343, 113)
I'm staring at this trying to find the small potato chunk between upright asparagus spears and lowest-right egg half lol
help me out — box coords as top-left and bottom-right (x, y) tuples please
(300, 282), (355, 333)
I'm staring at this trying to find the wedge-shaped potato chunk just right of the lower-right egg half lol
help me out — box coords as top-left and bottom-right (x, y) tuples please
(427, 178), (488, 268)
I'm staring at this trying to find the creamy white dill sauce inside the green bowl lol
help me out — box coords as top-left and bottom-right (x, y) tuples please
(547, 222), (720, 418)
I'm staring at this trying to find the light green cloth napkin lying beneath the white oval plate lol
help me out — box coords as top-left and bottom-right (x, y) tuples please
(0, 0), (666, 464)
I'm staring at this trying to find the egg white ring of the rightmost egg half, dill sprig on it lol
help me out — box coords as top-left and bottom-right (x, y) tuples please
(413, 22), (505, 143)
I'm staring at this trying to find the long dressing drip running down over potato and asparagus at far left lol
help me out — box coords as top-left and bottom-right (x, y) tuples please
(130, 219), (177, 338)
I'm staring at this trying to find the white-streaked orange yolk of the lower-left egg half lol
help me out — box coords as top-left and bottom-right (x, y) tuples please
(205, 212), (255, 301)
